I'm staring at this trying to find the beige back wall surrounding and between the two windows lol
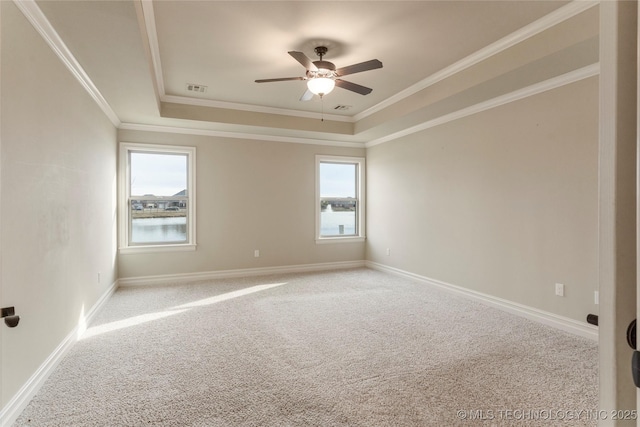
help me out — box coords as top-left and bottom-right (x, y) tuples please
(119, 130), (365, 278)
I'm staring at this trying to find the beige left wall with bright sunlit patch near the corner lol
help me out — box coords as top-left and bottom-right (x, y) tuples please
(0, 2), (117, 408)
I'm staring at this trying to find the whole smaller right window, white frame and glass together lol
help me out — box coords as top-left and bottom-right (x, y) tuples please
(316, 156), (365, 243)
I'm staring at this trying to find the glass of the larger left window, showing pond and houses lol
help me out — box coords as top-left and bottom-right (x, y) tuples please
(130, 152), (188, 244)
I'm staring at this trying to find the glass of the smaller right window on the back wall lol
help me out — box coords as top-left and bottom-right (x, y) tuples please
(319, 163), (358, 236)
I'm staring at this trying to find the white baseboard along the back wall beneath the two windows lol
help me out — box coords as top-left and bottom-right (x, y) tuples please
(119, 261), (365, 286)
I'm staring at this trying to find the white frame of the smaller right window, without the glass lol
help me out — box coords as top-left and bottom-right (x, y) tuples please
(316, 154), (366, 244)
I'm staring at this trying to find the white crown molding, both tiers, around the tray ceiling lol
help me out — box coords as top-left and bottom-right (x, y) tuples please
(14, 0), (600, 148)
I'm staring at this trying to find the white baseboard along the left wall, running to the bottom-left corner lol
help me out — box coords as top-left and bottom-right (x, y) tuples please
(0, 281), (118, 427)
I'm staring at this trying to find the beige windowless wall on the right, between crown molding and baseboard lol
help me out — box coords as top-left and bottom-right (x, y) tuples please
(367, 77), (598, 321)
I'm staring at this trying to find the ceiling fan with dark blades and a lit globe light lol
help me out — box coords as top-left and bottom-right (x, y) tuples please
(256, 46), (382, 101)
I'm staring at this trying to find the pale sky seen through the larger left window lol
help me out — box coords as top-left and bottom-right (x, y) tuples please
(131, 152), (187, 196)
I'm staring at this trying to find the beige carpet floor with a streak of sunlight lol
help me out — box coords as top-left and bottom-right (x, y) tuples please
(15, 269), (598, 427)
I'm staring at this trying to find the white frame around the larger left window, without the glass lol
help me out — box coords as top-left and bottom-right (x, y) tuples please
(118, 142), (196, 253)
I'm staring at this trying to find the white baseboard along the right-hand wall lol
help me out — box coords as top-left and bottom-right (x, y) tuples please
(365, 261), (598, 341)
